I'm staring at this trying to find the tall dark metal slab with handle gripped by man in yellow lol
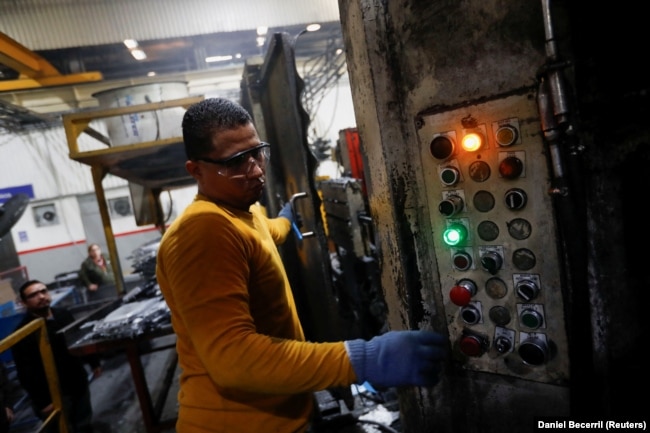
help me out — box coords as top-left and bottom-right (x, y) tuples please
(242, 33), (351, 341)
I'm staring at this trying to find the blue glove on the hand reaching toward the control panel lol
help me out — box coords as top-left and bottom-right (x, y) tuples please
(345, 331), (447, 387)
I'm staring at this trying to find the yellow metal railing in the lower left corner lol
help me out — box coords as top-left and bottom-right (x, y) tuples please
(0, 319), (68, 433)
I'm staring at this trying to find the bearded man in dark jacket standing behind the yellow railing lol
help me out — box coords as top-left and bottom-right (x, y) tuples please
(12, 280), (101, 433)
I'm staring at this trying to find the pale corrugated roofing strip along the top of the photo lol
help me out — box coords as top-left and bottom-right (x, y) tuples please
(0, 0), (339, 51)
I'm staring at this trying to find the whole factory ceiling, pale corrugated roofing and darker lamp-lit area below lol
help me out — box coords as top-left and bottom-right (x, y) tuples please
(0, 0), (344, 132)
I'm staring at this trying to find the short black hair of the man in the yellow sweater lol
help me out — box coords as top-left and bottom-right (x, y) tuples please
(182, 98), (253, 160)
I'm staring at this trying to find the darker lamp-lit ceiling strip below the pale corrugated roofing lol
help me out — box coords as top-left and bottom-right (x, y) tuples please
(0, 21), (344, 131)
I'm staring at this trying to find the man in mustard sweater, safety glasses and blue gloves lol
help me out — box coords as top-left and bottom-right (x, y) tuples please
(156, 98), (448, 433)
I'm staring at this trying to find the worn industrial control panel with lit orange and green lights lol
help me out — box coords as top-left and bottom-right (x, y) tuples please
(417, 93), (569, 384)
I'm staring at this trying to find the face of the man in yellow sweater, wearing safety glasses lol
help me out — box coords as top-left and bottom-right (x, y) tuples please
(185, 123), (269, 210)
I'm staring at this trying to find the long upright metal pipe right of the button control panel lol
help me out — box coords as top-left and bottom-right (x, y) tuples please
(538, 0), (603, 415)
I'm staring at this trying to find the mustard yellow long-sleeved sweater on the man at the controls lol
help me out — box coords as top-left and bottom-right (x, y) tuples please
(157, 194), (356, 433)
